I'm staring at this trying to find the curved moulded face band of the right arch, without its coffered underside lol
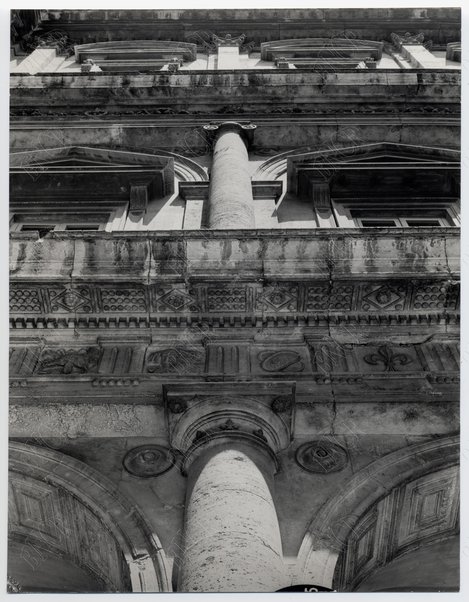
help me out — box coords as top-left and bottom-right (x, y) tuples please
(297, 436), (459, 587)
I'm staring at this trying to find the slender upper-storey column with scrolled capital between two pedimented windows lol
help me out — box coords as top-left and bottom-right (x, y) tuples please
(204, 121), (256, 230)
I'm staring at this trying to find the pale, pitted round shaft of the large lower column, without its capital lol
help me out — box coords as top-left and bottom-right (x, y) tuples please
(178, 441), (285, 592)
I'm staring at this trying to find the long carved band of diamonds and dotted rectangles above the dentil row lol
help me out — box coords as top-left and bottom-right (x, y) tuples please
(10, 280), (459, 322)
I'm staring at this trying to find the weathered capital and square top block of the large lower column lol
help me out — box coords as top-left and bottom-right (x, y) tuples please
(164, 382), (294, 474)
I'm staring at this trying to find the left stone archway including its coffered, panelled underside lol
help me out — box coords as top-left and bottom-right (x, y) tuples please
(9, 442), (171, 592)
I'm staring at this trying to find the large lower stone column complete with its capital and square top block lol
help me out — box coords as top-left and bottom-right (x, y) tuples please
(165, 382), (294, 593)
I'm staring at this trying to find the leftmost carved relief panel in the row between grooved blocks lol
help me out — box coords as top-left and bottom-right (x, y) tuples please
(37, 347), (101, 374)
